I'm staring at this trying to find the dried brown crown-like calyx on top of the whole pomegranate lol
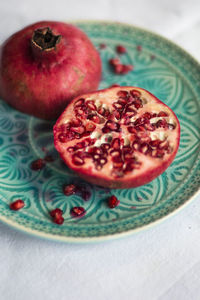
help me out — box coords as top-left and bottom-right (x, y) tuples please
(31, 27), (62, 51)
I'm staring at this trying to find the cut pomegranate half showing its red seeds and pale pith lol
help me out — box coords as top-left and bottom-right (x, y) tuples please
(54, 87), (180, 188)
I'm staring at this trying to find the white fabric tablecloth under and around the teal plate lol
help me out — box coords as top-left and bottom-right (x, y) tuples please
(0, 0), (200, 300)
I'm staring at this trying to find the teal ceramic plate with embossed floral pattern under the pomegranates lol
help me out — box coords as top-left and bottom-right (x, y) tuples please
(0, 22), (200, 242)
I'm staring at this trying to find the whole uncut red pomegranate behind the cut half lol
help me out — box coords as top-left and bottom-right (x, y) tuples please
(0, 21), (101, 120)
